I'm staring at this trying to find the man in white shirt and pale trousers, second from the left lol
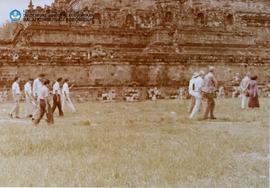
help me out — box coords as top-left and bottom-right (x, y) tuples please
(24, 78), (35, 118)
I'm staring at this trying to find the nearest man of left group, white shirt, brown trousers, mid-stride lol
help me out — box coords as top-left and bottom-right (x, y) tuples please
(34, 80), (53, 125)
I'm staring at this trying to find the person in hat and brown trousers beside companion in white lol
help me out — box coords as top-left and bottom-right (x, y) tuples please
(201, 66), (217, 120)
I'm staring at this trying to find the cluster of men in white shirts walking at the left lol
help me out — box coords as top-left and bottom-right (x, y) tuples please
(9, 74), (76, 125)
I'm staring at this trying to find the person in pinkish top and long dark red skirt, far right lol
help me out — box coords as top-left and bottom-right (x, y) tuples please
(248, 76), (260, 108)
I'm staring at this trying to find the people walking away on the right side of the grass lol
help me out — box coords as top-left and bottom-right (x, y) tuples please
(189, 66), (260, 120)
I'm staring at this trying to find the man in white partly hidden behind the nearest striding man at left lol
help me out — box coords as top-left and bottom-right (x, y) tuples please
(33, 74), (45, 119)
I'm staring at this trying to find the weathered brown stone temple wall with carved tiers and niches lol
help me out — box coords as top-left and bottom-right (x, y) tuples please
(0, 0), (270, 98)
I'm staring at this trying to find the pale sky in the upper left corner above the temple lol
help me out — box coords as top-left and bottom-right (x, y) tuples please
(0, 0), (54, 25)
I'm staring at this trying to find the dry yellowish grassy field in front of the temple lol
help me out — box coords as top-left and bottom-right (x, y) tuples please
(0, 99), (270, 188)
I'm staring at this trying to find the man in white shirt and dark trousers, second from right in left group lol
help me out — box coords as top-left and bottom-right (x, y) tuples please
(52, 78), (64, 116)
